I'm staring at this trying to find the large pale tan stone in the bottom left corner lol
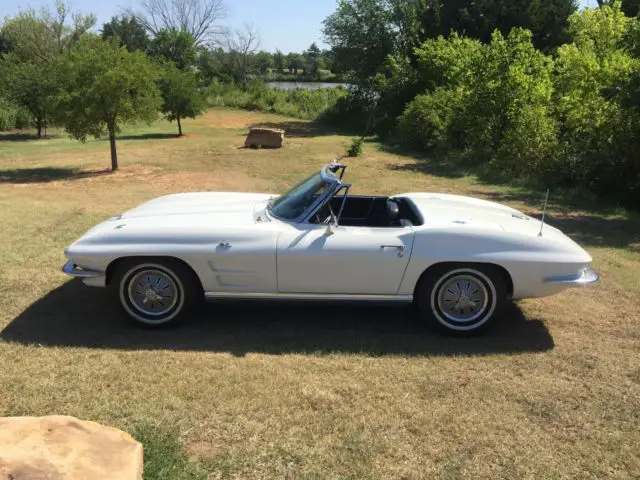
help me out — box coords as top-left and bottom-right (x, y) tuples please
(0, 416), (142, 480)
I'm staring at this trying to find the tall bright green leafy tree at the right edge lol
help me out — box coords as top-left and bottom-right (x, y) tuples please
(555, 3), (640, 202)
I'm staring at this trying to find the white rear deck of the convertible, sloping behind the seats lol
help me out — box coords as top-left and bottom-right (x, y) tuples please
(398, 193), (578, 247)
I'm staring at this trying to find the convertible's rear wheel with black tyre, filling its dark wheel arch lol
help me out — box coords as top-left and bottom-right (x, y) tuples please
(416, 264), (507, 333)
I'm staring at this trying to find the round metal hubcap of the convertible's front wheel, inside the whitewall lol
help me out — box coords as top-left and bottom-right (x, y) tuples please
(129, 270), (178, 316)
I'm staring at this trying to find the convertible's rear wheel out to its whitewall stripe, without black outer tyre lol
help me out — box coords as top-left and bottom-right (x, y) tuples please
(430, 268), (497, 331)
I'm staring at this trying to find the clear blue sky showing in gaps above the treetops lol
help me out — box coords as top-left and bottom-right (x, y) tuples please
(0, 0), (596, 53)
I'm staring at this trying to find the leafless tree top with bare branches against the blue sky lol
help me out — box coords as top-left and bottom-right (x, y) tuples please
(129, 0), (226, 46)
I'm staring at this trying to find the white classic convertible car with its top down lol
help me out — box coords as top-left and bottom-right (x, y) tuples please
(63, 164), (598, 332)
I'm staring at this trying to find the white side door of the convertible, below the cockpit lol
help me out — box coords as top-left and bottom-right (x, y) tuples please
(277, 225), (413, 295)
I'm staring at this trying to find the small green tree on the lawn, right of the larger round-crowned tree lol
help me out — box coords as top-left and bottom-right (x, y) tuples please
(158, 64), (206, 136)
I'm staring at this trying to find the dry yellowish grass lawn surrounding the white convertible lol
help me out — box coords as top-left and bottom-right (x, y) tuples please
(0, 110), (640, 479)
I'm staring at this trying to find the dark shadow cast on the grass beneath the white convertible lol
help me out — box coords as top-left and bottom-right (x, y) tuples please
(0, 280), (554, 356)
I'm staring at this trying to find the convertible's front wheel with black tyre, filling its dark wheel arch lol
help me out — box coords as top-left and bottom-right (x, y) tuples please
(112, 258), (202, 328)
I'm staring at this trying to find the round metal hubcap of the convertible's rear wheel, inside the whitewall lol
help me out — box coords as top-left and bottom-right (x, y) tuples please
(438, 275), (489, 323)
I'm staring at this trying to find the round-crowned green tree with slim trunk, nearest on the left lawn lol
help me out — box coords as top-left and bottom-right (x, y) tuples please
(59, 37), (160, 171)
